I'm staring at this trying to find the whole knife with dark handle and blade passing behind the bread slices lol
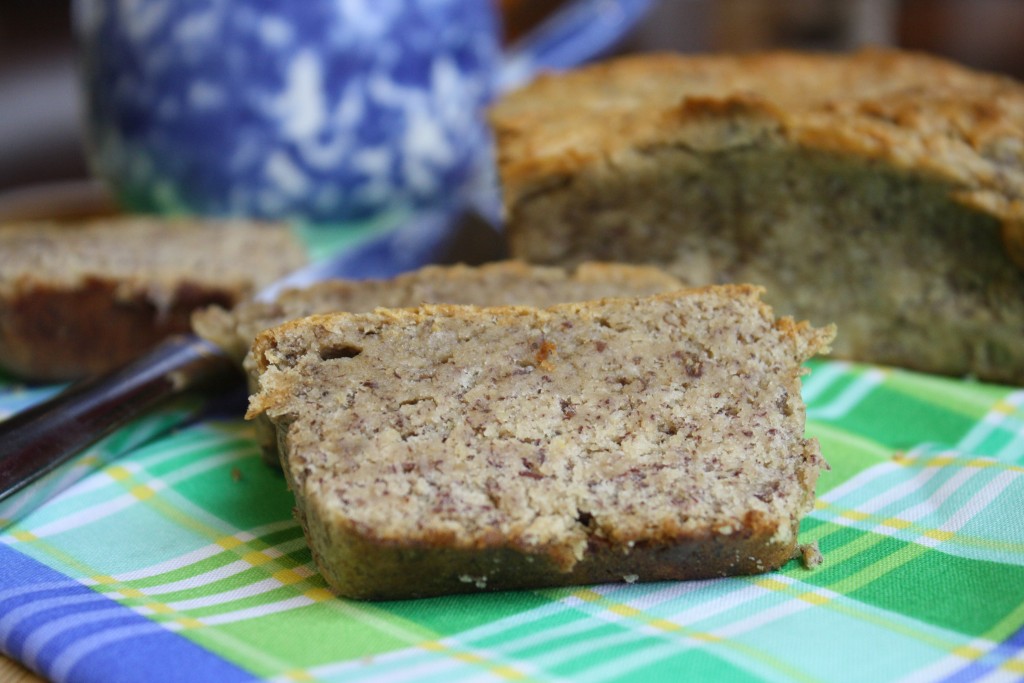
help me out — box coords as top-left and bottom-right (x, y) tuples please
(0, 202), (504, 528)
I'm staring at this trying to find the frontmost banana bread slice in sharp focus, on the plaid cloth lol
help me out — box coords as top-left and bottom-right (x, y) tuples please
(248, 286), (833, 599)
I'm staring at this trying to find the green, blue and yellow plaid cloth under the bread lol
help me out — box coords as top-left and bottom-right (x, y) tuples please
(0, 361), (1024, 683)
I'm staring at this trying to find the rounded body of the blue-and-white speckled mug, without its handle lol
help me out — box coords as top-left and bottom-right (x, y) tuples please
(75, 0), (501, 221)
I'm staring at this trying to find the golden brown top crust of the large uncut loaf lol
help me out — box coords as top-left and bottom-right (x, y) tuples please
(492, 49), (1024, 268)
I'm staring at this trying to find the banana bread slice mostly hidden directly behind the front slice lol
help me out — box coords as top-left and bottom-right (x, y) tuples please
(193, 261), (682, 465)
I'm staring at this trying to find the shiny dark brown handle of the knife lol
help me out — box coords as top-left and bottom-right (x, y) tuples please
(0, 335), (242, 516)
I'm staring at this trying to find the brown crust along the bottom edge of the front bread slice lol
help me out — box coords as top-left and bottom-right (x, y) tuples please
(286, 497), (797, 600)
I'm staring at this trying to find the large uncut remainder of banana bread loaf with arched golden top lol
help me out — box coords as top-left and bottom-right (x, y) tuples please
(493, 50), (1024, 384)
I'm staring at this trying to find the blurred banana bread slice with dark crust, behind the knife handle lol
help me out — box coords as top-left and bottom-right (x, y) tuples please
(0, 217), (306, 382)
